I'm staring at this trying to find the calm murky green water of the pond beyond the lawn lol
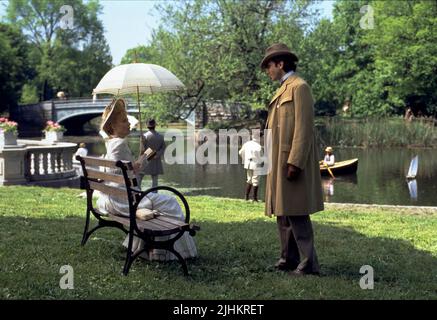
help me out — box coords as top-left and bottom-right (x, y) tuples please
(65, 136), (437, 206)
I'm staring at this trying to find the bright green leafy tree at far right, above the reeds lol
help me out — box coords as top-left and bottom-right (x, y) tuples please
(364, 0), (437, 116)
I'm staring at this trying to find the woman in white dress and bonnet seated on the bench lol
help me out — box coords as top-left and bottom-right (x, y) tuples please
(97, 99), (197, 261)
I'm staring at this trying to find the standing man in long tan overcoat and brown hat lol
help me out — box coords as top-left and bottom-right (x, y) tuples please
(261, 43), (324, 275)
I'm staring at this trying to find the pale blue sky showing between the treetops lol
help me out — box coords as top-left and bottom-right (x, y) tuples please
(0, 0), (334, 65)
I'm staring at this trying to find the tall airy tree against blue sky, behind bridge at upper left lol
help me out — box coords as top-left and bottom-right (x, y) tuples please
(7, 0), (112, 100)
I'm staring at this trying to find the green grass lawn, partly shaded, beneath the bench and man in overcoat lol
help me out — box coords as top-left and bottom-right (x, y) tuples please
(0, 187), (437, 300)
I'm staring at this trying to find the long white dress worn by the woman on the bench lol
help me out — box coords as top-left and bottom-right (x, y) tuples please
(97, 138), (197, 261)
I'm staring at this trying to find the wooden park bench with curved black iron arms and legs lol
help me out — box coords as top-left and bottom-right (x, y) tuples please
(76, 156), (200, 275)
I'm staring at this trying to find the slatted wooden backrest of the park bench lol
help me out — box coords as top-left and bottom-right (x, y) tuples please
(76, 156), (140, 205)
